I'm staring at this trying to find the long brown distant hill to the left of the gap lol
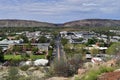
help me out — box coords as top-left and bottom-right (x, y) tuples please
(0, 19), (55, 27)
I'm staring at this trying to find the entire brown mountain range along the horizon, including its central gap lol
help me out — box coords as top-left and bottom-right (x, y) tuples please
(0, 19), (120, 27)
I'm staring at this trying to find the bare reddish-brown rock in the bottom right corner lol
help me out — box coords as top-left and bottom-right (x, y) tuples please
(98, 71), (120, 80)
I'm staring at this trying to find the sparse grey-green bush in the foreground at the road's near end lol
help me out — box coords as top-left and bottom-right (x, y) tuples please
(49, 59), (73, 77)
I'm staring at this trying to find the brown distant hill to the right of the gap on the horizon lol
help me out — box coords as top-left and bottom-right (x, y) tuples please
(63, 19), (120, 27)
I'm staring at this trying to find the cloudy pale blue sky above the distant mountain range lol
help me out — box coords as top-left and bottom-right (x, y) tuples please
(0, 0), (120, 23)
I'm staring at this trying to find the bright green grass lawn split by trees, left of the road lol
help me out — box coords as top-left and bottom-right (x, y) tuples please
(4, 55), (45, 60)
